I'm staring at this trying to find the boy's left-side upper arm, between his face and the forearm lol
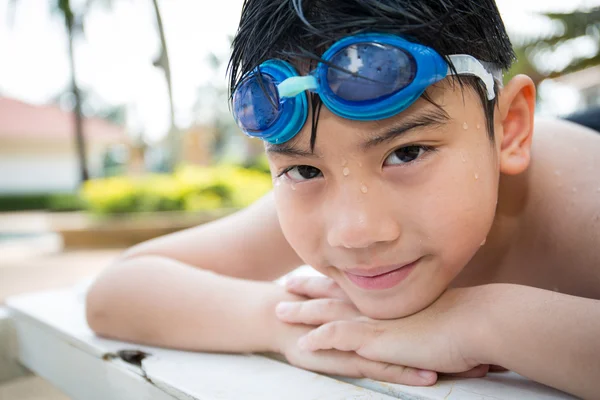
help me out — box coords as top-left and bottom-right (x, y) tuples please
(117, 193), (302, 281)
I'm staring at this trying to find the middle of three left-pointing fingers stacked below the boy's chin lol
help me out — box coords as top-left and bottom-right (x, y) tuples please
(275, 299), (360, 325)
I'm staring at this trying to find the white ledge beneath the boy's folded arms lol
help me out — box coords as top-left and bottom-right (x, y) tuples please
(7, 286), (573, 400)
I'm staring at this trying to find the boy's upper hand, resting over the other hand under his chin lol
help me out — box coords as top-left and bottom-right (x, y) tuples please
(277, 277), (489, 384)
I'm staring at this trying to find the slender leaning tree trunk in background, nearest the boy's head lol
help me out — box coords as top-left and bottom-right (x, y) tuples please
(152, 0), (181, 167)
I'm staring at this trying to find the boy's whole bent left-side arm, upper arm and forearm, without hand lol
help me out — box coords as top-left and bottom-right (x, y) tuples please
(86, 195), (300, 351)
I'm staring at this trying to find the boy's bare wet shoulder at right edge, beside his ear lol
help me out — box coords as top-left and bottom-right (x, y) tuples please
(526, 115), (600, 298)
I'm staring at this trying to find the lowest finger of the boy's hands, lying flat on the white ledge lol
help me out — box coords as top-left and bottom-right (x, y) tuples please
(293, 350), (437, 386)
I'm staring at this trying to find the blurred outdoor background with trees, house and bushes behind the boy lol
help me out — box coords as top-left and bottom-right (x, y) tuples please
(0, 0), (600, 398)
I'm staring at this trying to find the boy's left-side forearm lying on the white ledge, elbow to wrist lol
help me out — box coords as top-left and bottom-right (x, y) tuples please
(87, 256), (300, 352)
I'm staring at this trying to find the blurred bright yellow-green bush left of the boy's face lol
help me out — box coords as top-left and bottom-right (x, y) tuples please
(81, 165), (272, 214)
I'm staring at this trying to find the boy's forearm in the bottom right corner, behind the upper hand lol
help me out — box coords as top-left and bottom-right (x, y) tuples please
(478, 284), (600, 398)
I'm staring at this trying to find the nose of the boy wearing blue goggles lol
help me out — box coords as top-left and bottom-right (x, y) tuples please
(327, 183), (401, 249)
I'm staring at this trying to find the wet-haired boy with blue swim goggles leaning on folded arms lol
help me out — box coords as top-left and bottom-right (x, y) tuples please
(87, 0), (600, 398)
